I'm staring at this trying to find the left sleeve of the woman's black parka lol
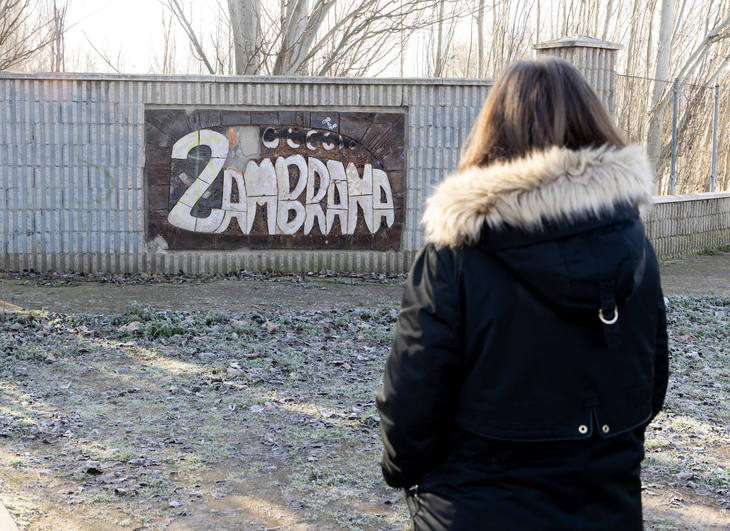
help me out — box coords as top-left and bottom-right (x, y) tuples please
(376, 245), (463, 488)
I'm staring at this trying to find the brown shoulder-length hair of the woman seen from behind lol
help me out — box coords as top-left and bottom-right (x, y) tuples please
(459, 56), (626, 170)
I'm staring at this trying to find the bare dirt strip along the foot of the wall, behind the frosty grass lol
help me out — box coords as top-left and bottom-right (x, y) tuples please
(0, 251), (730, 313)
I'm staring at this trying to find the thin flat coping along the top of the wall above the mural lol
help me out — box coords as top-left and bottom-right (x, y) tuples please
(0, 71), (494, 86)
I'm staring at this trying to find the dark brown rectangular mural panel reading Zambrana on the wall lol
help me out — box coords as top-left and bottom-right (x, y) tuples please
(145, 109), (405, 250)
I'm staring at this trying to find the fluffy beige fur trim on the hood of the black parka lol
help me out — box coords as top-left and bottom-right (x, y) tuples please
(422, 145), (654, 247)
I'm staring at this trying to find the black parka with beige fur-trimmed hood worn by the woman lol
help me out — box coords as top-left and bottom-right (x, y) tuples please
(377, 146), (667, 529)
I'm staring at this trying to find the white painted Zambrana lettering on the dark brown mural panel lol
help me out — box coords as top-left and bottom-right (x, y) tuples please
(167, 128), (395, 235)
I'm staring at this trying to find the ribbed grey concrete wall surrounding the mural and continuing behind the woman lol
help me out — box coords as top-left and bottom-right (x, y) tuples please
(0, 73), (730, 273)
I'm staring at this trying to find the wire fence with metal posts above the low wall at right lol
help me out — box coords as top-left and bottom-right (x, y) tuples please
(616, 74), (730, 195)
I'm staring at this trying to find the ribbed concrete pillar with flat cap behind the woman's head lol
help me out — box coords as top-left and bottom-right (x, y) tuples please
(535, 35), (623, 115)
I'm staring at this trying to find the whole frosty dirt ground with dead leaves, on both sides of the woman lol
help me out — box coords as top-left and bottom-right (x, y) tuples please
(0, 253), (730, 530)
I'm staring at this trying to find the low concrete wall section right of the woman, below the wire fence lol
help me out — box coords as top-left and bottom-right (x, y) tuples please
(644, 193), (730, 259)
